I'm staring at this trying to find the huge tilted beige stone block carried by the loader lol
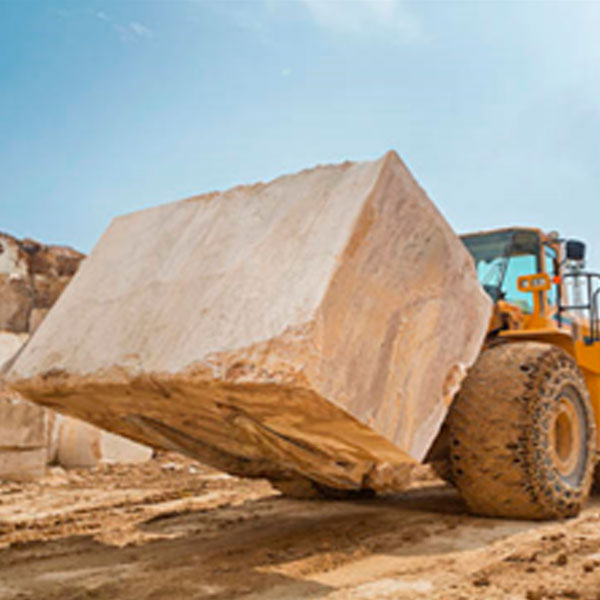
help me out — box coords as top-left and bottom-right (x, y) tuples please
(9, 153), (491, 489)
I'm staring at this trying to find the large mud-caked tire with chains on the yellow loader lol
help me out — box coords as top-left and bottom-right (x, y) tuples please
(448, 342), (596, 519)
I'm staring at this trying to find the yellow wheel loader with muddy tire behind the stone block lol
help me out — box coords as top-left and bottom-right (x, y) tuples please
(432, 228), (600, 519)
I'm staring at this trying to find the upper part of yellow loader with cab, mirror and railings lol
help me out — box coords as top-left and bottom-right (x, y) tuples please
(461, 228), (600, 345)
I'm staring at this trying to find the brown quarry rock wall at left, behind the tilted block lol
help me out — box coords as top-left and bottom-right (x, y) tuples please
(0, 234), (152, 480)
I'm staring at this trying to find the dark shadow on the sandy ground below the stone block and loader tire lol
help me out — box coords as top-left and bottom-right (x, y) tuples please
(0, 486), (540, 600)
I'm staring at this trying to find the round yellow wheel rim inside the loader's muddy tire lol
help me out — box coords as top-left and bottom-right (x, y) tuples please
(550, 385), (586, 485)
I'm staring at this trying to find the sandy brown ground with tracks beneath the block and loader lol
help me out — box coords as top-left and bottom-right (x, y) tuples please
(0, 455), (600, 600)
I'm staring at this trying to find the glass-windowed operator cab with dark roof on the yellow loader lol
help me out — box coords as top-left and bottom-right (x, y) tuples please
(461, 229), (558, 314)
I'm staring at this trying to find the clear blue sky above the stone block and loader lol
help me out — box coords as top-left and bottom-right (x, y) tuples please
(0, 0), (600, 268)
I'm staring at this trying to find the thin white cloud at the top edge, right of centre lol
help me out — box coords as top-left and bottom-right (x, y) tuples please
(298, 0), (426, 43)
